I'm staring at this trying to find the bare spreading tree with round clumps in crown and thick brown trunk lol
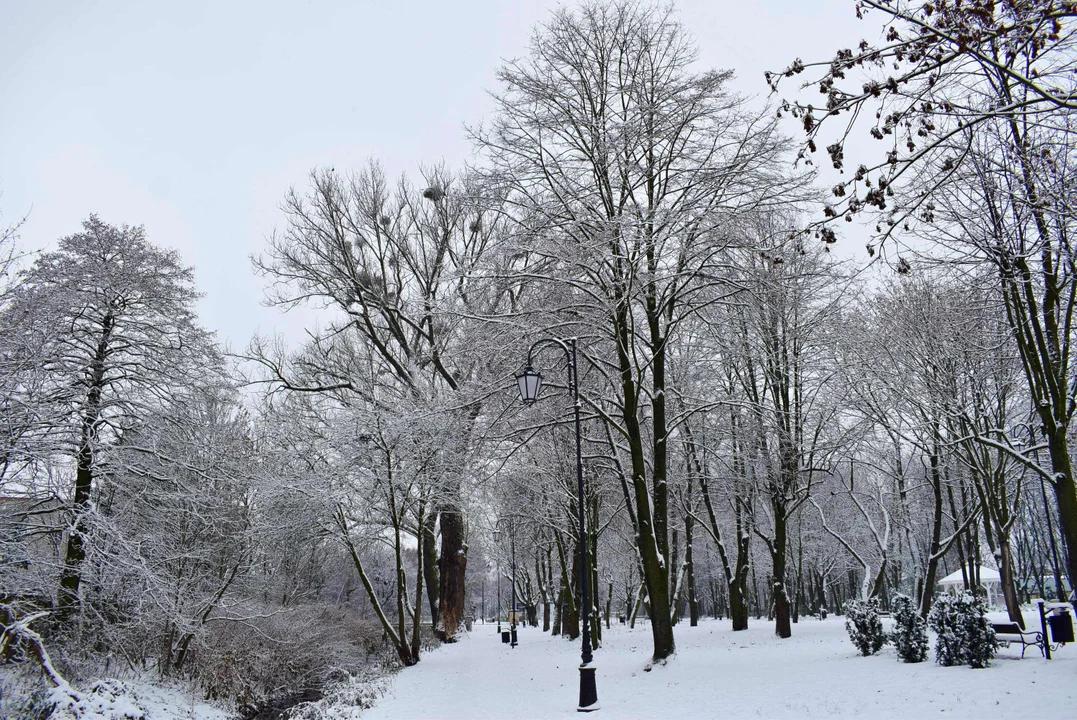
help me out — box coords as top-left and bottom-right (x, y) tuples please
(251, 163), (499, 641)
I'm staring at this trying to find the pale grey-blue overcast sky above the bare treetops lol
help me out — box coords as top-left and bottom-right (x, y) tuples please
(0, 0), (878, 349)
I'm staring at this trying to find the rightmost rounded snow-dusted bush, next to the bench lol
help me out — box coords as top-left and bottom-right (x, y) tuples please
(927, 593), (998, 667)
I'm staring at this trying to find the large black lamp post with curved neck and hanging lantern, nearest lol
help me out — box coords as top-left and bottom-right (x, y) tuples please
(516, 338), (599, 712)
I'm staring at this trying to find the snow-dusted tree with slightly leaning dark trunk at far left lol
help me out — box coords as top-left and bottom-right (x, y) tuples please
(5, 215), (219, 613)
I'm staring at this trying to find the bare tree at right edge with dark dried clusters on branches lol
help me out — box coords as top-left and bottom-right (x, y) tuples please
(769, 0), (1077, 594)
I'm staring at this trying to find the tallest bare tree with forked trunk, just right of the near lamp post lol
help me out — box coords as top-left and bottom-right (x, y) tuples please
(474, 2), (795, 660)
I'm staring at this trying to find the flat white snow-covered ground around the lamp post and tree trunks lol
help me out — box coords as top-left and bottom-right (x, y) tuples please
(363, 618), (1077, 720)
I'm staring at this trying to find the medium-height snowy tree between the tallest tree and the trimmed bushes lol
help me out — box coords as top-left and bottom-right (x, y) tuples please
(733, 215), (848, 637)
